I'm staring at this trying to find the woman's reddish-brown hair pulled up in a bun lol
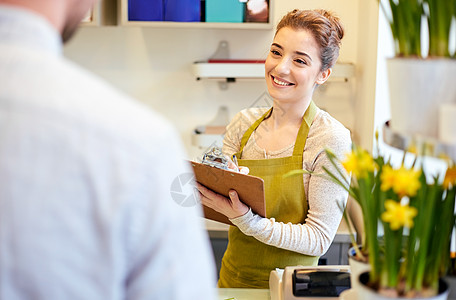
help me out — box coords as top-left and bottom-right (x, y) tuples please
(275, 9), (344, 71)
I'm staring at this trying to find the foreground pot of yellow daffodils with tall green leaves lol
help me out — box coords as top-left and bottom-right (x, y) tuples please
(325, 142), (456, 299)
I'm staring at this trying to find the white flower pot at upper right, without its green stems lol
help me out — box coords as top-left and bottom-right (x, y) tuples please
(387, 58), (456, 139)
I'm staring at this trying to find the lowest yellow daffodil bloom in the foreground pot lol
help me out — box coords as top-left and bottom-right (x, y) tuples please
(381, 200), (418, 230)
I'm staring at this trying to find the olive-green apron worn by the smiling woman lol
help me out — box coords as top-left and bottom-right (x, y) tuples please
(219, 102), (319, 288)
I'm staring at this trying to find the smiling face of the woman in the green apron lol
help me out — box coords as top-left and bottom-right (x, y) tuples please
(265, 27), (331, 103)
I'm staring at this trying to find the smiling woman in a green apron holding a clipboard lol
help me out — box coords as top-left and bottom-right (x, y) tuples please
(199, 10), (351, 288)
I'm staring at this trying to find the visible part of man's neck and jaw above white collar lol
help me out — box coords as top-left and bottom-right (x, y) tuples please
(0, 0), (97, 42)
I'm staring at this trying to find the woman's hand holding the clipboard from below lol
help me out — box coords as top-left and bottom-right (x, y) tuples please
(196, 183), (249, 219)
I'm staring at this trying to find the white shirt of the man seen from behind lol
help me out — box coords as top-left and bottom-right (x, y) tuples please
(0, 6), (216, 300)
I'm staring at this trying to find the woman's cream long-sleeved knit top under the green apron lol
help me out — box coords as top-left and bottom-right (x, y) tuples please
(223, 107), (351, 256)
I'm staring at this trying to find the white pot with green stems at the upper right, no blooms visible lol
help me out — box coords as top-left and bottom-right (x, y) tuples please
(378, 0), (456, 138)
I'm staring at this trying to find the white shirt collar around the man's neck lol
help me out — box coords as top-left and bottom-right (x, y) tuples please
(0, 5), (63, 56)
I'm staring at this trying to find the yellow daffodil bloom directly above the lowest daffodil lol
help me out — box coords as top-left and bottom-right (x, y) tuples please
(380, 165), (421, 198)
